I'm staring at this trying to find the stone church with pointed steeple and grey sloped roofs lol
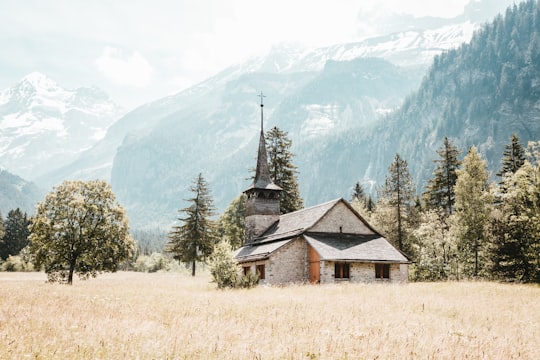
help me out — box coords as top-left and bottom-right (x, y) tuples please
(235, 94), (411, 285)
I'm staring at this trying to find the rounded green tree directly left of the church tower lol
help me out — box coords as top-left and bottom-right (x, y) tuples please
(218, 194), (246, 249)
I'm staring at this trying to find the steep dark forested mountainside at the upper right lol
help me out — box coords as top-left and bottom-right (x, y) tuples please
(358, 0), (540, 191)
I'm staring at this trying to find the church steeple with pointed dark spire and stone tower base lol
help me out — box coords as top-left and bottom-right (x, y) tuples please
(244, 92), (282, 243)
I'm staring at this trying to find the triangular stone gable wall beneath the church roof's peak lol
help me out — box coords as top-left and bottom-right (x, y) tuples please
(309, 203), (373, 234)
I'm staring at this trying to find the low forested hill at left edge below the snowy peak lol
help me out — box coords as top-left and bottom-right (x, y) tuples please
(0, 168), (44, 217)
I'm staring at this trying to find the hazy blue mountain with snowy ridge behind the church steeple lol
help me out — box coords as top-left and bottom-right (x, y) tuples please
(24, 0), (520, 228)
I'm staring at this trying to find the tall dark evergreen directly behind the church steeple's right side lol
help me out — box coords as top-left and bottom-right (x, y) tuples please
(265, 126), (304, 214)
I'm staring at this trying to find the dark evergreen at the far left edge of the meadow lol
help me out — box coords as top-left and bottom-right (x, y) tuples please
(0, 208), (30, 260)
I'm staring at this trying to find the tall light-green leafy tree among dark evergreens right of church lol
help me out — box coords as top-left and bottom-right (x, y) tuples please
(451, 146), (493, 277)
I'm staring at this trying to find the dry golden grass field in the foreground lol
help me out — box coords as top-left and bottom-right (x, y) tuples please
(0, 273), (540, 359)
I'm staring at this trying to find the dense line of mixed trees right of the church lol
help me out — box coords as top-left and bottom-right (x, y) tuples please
(353, 135), (540, 283)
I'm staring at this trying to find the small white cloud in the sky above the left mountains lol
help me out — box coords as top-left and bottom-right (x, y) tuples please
(95, 46), (154, 88)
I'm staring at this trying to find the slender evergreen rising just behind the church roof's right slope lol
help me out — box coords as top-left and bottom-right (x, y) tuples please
(377, 154), (414, 252)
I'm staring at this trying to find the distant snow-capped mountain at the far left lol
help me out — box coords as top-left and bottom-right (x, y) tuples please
(0, 72), (123, 180)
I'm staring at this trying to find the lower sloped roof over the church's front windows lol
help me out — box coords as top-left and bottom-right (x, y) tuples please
(304, 233), (410, 263)
